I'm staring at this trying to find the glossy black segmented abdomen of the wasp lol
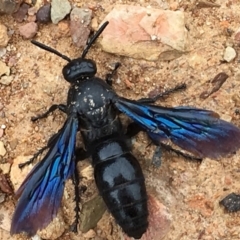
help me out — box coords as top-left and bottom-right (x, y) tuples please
(93, 140), (148, 239)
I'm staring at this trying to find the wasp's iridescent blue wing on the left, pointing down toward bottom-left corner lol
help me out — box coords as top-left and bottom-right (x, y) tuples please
(11, 117), (78, 236)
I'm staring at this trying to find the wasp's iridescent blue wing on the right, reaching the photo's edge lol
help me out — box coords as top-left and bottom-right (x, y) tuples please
(114, 98), (240, 159)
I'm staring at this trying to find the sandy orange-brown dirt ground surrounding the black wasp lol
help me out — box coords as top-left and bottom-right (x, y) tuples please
(0, 0), (240, 240)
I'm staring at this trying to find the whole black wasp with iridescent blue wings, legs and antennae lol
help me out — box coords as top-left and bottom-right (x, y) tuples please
(11, 22), (240, 239)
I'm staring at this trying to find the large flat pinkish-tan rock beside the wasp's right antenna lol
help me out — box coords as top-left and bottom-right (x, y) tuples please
(101, 5), (188, 60)
